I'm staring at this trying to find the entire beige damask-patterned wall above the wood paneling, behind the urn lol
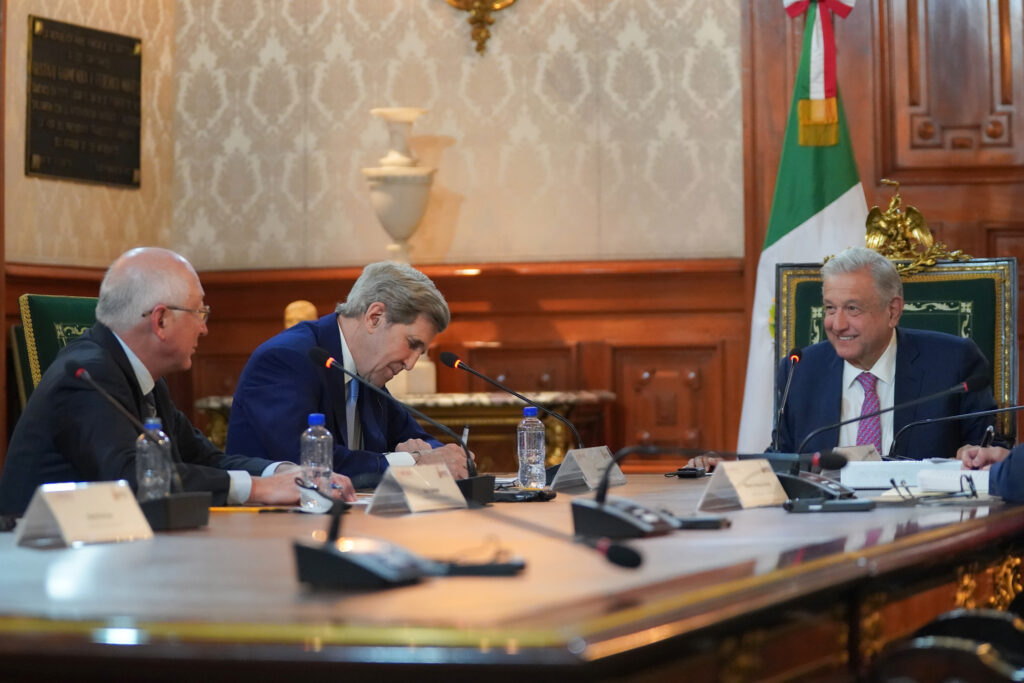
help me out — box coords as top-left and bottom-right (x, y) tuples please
(0, 0), (743, 269)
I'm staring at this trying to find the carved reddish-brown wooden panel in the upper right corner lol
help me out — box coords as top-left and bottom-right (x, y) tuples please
(876, 0), (1024, 183)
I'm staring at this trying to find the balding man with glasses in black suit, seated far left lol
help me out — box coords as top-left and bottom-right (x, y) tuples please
(0, 248), (354, 515)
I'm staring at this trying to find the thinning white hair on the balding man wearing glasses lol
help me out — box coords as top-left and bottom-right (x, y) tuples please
(96, 247), (197, 331)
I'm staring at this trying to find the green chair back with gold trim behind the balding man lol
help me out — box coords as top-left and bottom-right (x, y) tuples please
(17, 294), (96, 389)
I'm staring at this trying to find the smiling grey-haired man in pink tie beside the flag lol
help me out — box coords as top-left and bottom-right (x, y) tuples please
(775, 247), (995, 460)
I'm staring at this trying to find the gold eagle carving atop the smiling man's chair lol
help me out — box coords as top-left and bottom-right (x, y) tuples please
(864, 178), (971, 275)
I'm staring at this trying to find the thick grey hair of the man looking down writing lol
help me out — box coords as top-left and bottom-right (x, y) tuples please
(335, 261), (452, 333)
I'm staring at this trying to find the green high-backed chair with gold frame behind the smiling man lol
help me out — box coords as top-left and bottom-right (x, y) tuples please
(775, 258), (1017, 435)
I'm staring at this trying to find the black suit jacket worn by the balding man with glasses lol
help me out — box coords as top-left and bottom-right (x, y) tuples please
(0, 323), (270, 514)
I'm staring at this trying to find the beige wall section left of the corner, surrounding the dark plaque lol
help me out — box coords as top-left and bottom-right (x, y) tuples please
(4, 0), (174, 266)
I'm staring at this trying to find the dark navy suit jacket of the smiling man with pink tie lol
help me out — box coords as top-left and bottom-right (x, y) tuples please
(775, 328), (995, 460)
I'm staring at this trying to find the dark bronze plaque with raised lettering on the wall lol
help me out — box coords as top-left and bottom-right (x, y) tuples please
(25, 15), (142, 187)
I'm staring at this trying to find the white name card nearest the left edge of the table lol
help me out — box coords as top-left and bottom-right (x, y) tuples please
(15, 479), (153, 547)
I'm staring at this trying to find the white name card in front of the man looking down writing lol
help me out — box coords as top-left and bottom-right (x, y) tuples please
(367, 465), (466, 514)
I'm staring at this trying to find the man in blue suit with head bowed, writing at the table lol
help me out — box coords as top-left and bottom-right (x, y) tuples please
(227, 261), (468, 487)
